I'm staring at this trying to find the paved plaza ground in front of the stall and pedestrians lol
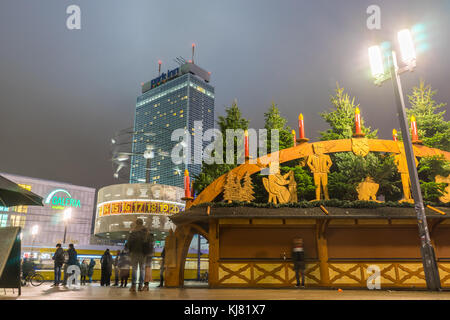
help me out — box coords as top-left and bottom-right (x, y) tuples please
(0, 282), (450, 300)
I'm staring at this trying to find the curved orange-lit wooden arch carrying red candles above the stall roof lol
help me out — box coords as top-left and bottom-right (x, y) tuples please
(186, 138), (450, 209)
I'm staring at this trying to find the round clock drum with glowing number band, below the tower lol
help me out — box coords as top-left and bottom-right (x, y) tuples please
(94, 183), (185, 240)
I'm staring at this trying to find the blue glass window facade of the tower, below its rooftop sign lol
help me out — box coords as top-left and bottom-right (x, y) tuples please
(130, 74), (214, 188)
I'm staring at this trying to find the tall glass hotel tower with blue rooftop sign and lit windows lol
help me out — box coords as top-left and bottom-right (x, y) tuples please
(130, 62), (214, 188)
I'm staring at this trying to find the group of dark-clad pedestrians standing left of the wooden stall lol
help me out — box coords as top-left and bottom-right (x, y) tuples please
(47, 219), (165, 292)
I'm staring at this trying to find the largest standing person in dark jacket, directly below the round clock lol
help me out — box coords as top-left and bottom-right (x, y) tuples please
(127, 218), (148, 292)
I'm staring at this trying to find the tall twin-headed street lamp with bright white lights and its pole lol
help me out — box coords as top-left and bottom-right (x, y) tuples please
(369, 30), (441, 291)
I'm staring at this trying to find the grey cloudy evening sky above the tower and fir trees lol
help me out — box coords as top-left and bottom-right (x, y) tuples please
(0, 0), (450, 187)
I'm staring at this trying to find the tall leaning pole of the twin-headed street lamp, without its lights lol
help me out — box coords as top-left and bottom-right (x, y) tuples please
(390, 52), (441, 291)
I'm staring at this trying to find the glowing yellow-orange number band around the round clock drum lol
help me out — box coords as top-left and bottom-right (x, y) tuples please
(97, 200), (184, 217)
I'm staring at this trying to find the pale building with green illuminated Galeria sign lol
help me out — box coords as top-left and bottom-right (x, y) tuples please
(0, 173), (95, 247)
